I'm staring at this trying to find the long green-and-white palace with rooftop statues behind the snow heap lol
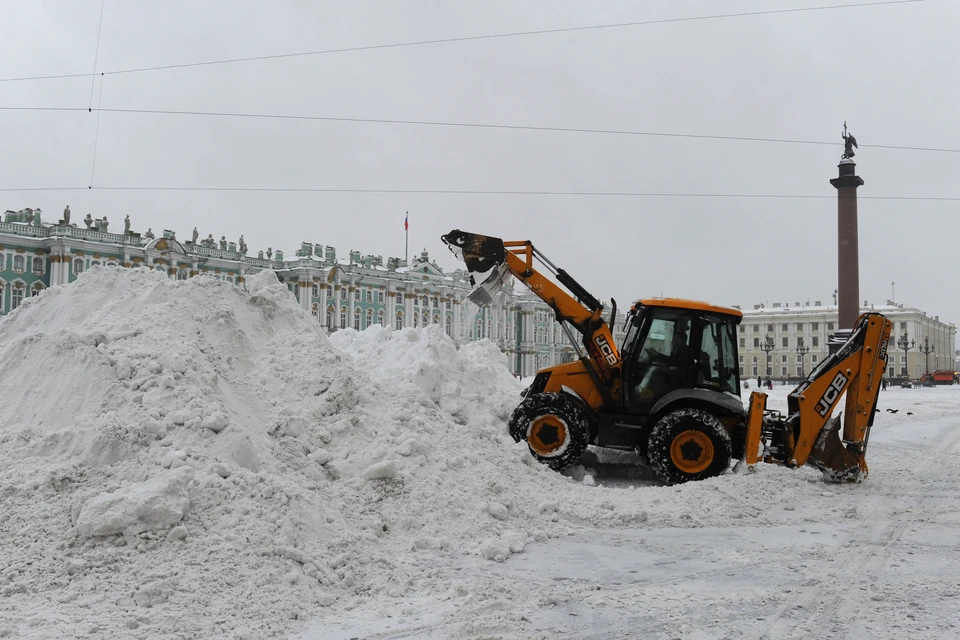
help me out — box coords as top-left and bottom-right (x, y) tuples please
(0, 207), (575, 376)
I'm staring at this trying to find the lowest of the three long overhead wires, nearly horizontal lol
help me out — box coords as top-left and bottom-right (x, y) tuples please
(0, 186), (960, 202)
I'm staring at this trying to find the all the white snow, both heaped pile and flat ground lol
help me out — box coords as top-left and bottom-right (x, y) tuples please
(0, 268), (960, 640)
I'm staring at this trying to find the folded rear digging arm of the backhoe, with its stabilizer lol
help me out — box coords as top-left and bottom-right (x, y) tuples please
(743, 313), (892, 482)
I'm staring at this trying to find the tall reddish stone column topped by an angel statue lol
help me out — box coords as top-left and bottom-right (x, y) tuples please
(830, 122), (863, 331)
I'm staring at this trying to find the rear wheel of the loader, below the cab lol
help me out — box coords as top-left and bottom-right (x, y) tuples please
(647, 409), (732, 484)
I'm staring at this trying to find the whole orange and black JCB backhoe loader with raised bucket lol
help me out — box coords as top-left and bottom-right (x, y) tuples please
(441, 230), (891, 484)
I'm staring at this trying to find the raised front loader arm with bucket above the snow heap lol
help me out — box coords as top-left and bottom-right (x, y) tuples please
(440, 229), (621, 393)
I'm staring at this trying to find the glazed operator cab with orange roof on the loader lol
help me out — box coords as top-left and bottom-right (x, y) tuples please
(621, 298), (743, 415)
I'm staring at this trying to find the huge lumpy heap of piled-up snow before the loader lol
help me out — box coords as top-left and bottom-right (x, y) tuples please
(0, 267), (814, 638)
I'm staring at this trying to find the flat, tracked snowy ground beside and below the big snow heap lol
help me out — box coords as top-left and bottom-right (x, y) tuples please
(306, 387), (960, 640)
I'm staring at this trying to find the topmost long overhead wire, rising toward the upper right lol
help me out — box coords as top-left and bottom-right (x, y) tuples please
(0, 0), (928, 82)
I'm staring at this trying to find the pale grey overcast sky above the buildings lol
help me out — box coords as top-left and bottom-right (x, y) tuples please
(0, 0), (960, 322)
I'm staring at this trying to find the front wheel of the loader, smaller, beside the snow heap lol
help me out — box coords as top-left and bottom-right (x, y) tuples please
(510, 393), (590, 471)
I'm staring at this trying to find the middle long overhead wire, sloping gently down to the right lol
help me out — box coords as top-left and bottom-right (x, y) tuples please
(0, 107), (960, 153)
